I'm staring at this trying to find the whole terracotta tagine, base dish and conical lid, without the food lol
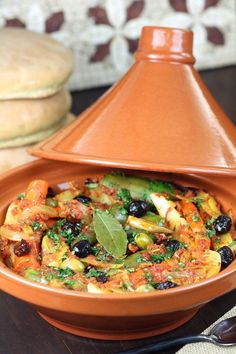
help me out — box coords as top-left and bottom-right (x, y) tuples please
(0, 27), (236, 339)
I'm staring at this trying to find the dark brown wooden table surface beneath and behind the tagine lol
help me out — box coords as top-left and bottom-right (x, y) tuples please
(0, 67), (236, 354)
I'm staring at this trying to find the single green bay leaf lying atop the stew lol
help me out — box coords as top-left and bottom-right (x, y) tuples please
(93, 211), (128, 259)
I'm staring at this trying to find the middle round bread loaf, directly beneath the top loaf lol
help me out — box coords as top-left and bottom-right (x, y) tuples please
(0, 90), (71, 148)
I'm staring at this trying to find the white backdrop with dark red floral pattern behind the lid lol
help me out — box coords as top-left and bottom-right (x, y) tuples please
(0, 0), (236, 89)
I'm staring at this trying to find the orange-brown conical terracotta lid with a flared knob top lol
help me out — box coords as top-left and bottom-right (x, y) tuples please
(31, 27), (236, 175)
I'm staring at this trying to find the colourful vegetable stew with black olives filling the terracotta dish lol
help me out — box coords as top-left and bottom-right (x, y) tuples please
(0, 173), (236, 294)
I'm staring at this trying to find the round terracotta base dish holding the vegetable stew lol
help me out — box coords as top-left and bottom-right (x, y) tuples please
(0, 160), (236, 339)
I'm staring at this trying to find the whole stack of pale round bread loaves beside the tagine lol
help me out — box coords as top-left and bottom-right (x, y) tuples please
(0, 28), (73, 173)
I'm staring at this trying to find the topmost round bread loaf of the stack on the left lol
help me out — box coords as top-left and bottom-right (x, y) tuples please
(0, 28), (73, 99)
